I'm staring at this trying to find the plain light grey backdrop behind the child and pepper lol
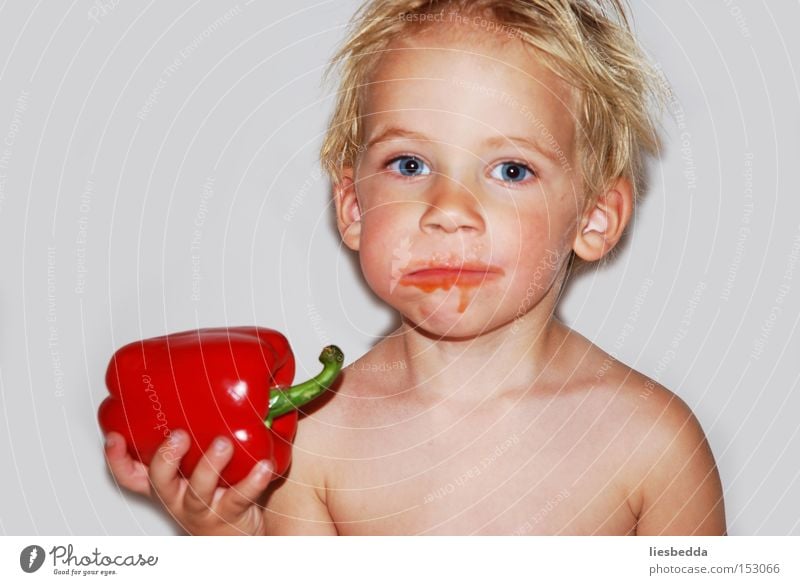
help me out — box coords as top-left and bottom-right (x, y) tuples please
(0, 0), (800, 535)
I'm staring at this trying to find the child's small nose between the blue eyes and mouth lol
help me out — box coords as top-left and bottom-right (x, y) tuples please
(420, 174), (485, 234)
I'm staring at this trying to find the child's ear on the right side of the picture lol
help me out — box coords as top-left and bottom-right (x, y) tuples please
(572, 177), (633, 262)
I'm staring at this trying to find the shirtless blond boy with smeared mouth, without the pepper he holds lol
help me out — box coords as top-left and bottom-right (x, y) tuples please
(107, 0), (725, 535)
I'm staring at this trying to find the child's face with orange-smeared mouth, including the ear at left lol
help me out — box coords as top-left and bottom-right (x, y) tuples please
(337, 30), (582, 337)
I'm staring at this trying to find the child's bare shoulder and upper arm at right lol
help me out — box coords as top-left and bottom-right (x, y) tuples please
(564, 328), (726, 535)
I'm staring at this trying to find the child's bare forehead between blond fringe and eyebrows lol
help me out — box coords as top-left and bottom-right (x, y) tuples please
(362, 24), (575, 152)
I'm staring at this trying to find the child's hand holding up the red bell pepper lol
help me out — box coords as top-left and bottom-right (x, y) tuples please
(105, 431), (273, 535)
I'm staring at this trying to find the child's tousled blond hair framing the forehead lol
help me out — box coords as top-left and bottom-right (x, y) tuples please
(320, 0), (664, 268)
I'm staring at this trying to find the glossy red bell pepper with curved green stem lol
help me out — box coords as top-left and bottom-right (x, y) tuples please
(98, 326), (344, 485)
